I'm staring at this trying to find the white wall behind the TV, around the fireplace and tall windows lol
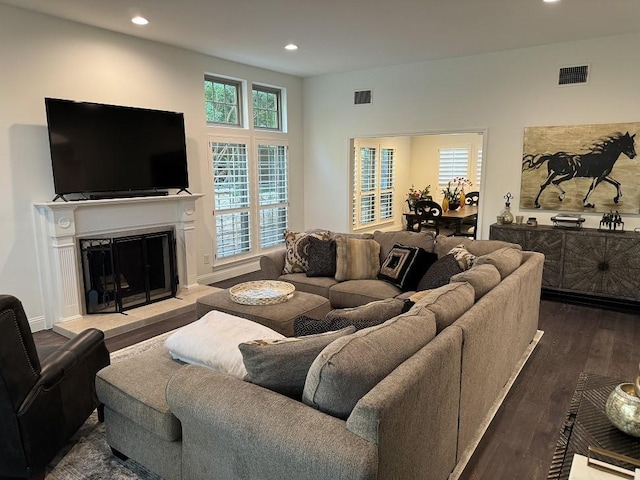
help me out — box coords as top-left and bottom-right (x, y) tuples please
(0, 5), (304, 325)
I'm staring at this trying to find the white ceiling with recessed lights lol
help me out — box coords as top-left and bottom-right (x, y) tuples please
(0, 0), (640, 77)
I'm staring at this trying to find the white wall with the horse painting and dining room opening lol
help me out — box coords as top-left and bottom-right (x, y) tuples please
(304, 34), (640, 238)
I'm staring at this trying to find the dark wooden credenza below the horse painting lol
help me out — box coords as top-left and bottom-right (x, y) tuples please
(490, 224), (640, 308)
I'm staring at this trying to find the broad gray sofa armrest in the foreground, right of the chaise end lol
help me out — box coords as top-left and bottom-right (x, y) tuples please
(166, 365), (378, 480)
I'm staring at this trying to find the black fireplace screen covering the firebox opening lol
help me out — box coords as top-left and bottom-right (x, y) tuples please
(80, 231), (178, 313)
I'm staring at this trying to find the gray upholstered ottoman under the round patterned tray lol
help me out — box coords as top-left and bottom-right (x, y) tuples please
(196, 290), (331, 337)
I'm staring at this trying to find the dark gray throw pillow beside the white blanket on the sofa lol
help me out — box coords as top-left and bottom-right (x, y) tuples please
(238, 326), (355, 398)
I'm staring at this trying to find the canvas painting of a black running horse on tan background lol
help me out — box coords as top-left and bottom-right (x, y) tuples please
(520, 123), (640, 214)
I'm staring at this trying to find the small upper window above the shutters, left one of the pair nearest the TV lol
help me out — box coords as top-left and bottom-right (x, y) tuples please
(204, 76), (242, 126)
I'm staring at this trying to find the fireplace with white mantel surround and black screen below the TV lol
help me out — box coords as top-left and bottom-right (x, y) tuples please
(35, 194), (203, 328)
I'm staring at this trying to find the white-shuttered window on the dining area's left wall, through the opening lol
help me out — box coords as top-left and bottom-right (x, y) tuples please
(353, 145), (395, 228)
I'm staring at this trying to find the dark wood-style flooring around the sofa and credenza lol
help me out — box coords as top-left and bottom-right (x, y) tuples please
(34, 294), (640, 480)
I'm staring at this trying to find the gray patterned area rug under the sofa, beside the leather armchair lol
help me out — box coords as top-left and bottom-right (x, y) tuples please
(46, 332), (173, 480)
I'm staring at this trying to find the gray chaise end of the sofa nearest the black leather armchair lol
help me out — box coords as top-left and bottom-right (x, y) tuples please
(96, 343), (184, 480)
